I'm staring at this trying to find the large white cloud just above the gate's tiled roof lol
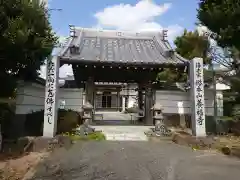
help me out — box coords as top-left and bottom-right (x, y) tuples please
(94, 0), (183, 41)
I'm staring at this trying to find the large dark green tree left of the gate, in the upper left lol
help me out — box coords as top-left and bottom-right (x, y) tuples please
(0, 0), (57, 96)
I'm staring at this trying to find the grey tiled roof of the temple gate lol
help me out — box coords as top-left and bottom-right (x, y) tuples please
(60, 28), (187, 64)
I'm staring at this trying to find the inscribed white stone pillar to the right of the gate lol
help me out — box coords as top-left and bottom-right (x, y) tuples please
(189, 58), (206, 137)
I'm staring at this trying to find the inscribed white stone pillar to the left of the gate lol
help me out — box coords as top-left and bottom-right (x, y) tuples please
(43, 56), (60, 137)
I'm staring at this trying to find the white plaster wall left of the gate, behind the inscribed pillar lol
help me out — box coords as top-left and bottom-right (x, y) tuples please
(16, 83), (83, 114)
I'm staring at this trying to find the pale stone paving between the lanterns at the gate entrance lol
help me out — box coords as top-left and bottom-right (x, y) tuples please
(94, 126), (150, 141)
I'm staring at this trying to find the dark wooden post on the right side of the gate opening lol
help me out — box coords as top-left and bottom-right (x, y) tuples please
(144, 83), (154, 125)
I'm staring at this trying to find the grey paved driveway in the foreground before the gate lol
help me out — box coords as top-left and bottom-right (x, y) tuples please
(28, 141), (240, 180)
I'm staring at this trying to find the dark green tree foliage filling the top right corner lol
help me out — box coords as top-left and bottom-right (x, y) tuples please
(197, 0), (240, 50)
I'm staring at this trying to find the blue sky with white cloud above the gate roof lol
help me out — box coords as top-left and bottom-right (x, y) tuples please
(48, 0), (198, 39)
